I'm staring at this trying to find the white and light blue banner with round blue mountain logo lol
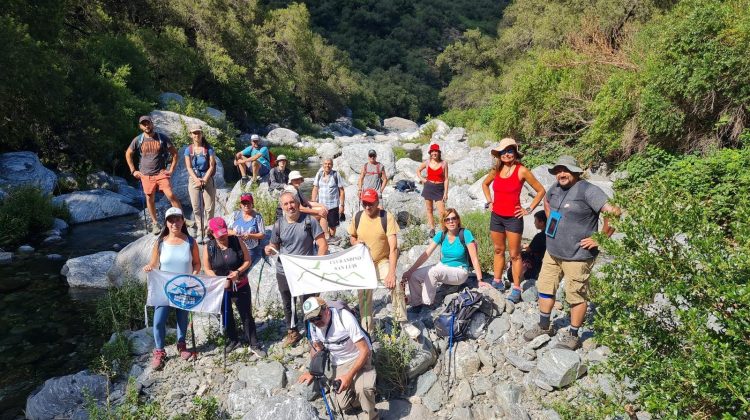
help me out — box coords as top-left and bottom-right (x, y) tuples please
(146, 270), (226, 314)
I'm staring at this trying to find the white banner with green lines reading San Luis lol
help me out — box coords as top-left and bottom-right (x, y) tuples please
(279, 244), (378, 296)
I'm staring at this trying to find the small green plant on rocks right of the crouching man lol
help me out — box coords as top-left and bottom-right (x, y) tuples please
(374, 323), (416, 398)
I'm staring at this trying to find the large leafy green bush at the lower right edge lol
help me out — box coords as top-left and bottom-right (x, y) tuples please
(592, 149), (750, 418)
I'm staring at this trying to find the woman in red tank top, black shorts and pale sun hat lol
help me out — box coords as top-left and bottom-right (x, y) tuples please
(480, 138), (546, 303)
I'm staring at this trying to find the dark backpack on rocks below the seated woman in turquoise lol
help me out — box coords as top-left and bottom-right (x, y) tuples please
(434, 287), (495, 343)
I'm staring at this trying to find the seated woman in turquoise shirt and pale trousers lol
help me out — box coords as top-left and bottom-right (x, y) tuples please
(403, 208), (482, 310)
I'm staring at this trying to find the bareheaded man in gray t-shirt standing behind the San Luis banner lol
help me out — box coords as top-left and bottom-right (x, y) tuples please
(266, 191), (328, 346)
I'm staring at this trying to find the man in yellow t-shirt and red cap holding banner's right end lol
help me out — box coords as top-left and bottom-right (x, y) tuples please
(349, 188), (406, 334)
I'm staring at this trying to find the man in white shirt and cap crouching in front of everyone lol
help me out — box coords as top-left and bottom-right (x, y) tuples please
(299, 297), (378, 419)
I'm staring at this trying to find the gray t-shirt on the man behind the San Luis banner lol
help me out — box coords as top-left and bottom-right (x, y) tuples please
(271, 213), (323, 274)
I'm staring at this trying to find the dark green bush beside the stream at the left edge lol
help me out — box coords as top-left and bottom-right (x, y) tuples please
(0, 186), (70, 246)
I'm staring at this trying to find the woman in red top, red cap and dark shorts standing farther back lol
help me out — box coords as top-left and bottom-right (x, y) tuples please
(417, 144), (448, 237)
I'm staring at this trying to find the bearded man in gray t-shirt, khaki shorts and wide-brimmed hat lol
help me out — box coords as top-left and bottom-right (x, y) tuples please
(523, 156), (620, 350)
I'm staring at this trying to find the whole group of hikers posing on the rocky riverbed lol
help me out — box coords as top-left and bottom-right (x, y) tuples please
(126, 116), (620, 418)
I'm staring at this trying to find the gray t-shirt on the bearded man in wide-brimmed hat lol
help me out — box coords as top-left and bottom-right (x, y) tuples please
(547, 180), (609, 261)
